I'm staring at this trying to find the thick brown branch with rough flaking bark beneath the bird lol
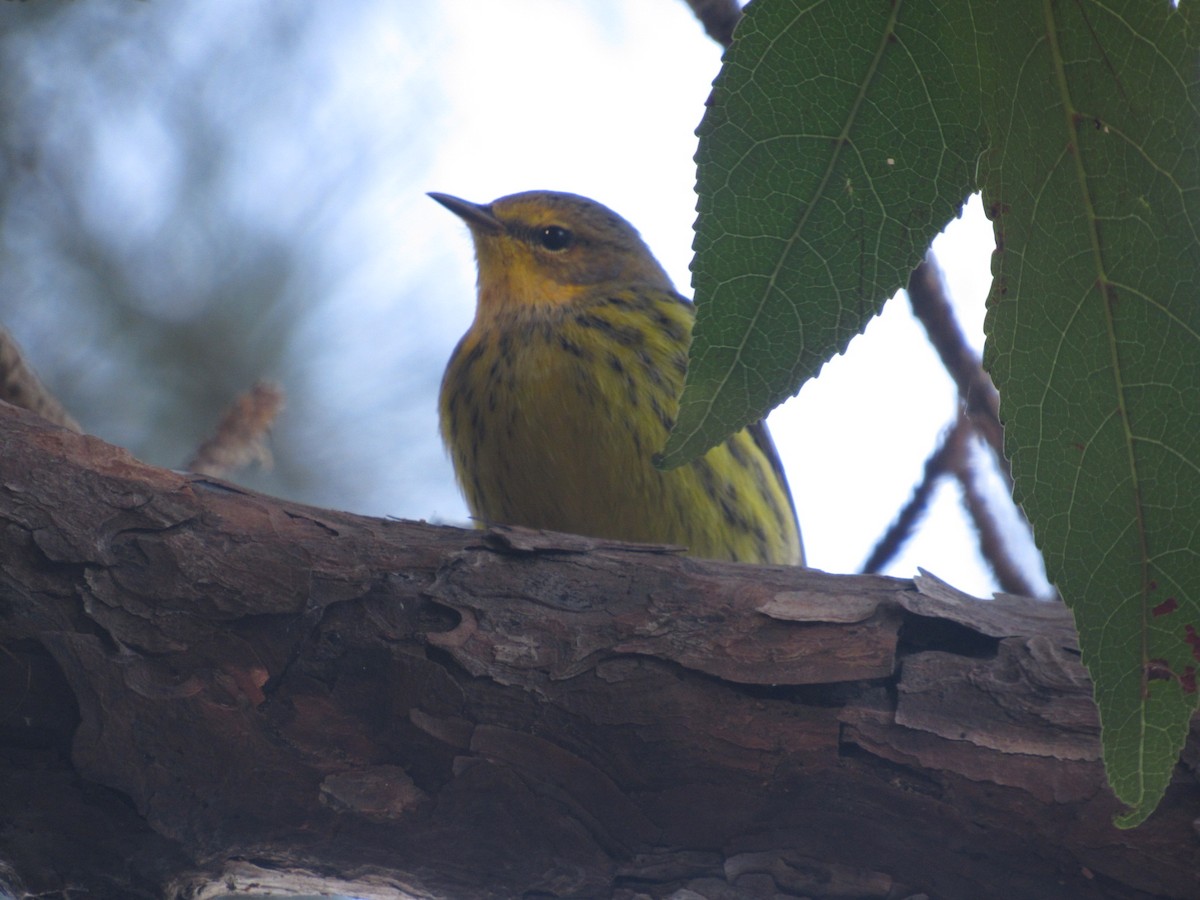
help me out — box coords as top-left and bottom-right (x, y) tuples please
(0, 404), (1200, 900)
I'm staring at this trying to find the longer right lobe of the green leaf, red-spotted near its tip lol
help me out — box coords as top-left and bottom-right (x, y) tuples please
(977, 0), (1200, 826)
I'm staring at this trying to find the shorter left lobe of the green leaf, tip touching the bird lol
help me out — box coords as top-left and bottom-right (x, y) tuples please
(661, 0), (982, 467)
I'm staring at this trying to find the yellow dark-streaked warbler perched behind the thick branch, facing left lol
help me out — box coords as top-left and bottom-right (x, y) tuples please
(430, 191), (804, 563)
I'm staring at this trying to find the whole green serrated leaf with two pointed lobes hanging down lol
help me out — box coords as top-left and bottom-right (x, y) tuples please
(665, 0), (1200, 826)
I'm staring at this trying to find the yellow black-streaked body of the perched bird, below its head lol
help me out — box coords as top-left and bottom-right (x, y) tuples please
(440, 287), (802, 563)
